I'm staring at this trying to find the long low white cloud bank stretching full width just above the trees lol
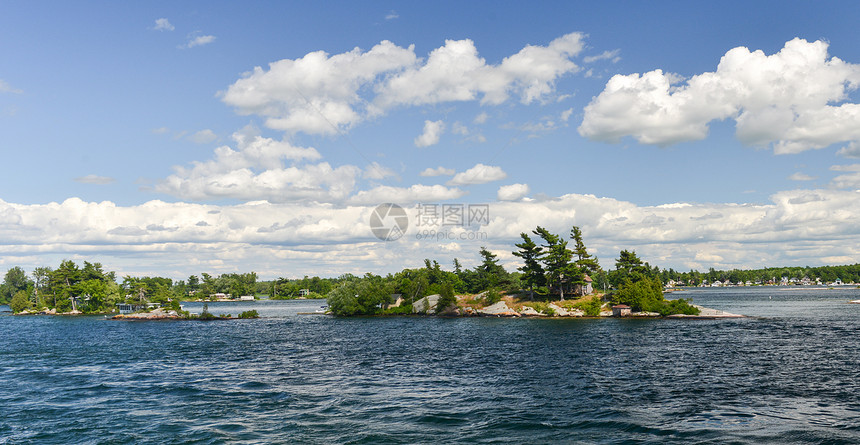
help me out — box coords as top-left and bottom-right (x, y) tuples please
(0, 186), (860, 278)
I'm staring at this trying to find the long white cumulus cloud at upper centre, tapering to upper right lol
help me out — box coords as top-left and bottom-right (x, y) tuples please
(220, 33), (584, 134)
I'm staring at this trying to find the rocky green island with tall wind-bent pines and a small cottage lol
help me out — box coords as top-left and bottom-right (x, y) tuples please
(328, 226), (698, 316)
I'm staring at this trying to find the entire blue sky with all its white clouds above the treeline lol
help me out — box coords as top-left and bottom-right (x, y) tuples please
(0, 1), (860, 278)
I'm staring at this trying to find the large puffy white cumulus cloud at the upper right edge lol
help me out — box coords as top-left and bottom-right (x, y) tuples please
(579, 38), (860, 154)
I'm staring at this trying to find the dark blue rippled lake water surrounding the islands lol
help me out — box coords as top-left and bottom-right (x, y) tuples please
(0, 288), (860, 443)
